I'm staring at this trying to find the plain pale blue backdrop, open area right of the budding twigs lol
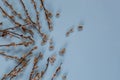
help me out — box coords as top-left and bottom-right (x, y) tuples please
(0, 0), (120, 80)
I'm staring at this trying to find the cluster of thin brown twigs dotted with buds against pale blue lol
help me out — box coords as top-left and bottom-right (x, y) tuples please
(0, 0), (83, 80)
